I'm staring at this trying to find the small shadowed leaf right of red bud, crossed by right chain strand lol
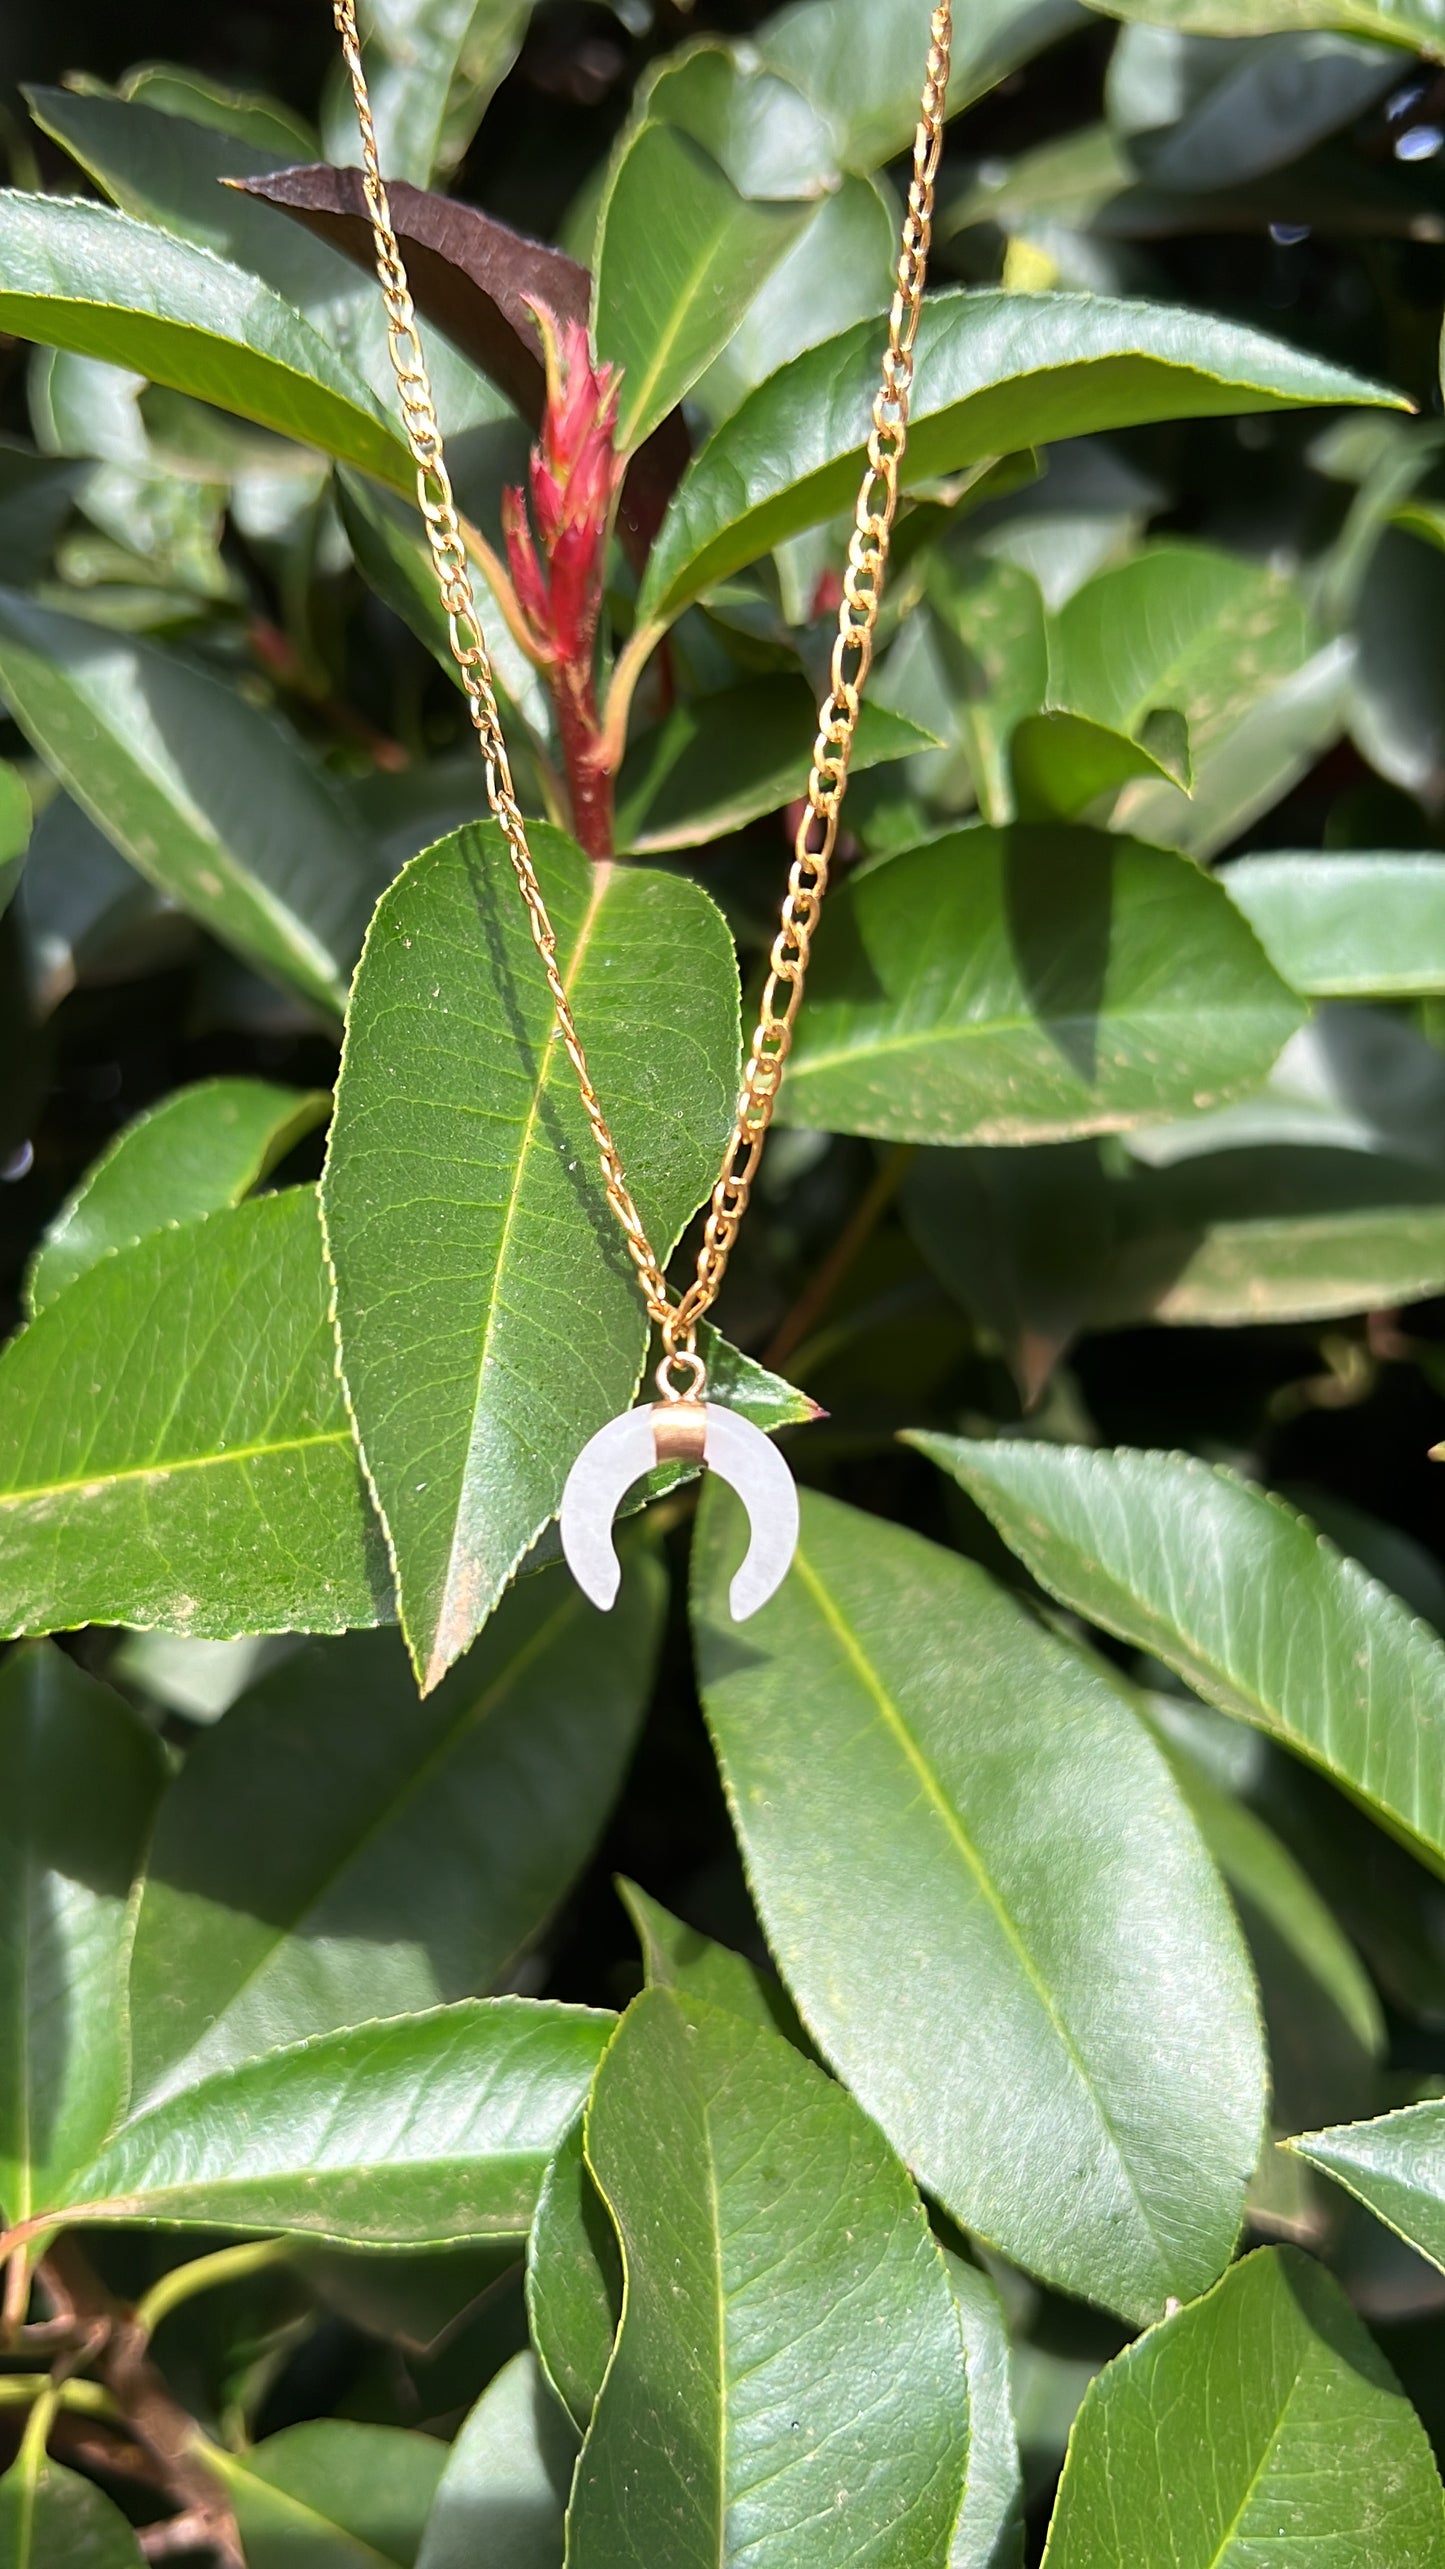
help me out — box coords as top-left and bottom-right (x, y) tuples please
(617, 678), (936, 855)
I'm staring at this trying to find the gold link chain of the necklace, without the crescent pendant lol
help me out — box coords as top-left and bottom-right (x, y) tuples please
(334, 0), (954, 1398)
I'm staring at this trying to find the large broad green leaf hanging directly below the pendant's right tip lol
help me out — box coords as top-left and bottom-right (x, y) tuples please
(697, 1490), (1265, 2320)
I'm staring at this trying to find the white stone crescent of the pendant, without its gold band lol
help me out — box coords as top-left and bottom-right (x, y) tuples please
(561, 1400), (797, 1624)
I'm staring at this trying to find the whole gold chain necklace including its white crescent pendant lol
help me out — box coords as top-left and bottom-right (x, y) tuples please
(334, 0), (954, 1621)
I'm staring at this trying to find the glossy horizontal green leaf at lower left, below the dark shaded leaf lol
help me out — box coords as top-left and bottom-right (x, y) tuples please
(21, 1999), (615, 2248)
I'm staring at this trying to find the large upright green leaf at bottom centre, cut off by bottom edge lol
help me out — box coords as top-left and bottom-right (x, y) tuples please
(568, 1988), (967, 2569)
